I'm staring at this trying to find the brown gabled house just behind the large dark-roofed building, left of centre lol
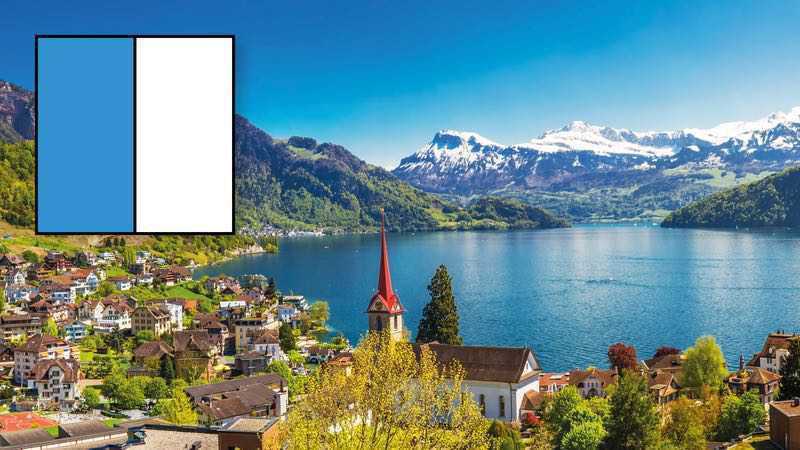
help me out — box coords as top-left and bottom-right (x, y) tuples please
(173, 330), (217, 381)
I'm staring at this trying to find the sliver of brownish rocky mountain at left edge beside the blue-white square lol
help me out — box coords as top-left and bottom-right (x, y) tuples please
(0, 80), (36, 142)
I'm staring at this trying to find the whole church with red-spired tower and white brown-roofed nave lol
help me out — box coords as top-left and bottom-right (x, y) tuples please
(367, 213), (542, 422)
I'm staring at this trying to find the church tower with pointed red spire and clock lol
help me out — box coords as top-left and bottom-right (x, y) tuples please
(367, 211), (405, 341)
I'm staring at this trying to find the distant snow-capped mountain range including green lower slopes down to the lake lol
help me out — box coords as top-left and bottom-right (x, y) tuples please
(392, 107), (800, 220)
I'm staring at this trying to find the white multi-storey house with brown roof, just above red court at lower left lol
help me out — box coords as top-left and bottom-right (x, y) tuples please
(33, 358), (81, 410)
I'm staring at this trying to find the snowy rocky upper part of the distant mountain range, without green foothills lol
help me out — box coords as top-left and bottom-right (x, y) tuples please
(393, 107), (800, 194)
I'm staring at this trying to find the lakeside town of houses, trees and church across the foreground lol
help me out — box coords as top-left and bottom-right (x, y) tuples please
(0, 221), (800, 449)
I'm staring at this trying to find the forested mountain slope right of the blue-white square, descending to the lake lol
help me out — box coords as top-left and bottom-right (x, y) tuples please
(235, 116), (568, 231)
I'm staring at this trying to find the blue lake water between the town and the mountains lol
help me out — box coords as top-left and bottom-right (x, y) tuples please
(195, 226), (800, 371)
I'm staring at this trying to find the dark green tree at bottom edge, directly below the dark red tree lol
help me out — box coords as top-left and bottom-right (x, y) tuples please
(606, 371), (661, 450)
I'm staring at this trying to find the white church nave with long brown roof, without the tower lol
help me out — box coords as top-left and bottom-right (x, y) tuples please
(412, 343), (541, 421)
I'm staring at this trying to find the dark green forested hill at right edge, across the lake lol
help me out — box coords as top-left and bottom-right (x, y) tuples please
(661, 168), (800, 228)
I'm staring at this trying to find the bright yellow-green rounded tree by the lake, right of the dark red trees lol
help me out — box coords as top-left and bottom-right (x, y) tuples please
(681, 336), (728, 390)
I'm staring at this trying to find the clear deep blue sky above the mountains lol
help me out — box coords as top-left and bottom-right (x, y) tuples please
(0, 0), (800, 168)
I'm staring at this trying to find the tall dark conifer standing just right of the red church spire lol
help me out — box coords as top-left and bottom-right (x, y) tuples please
(417, 265), (463, 345)
